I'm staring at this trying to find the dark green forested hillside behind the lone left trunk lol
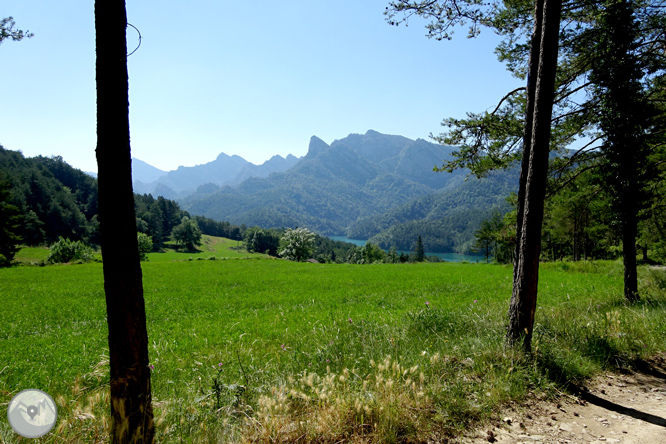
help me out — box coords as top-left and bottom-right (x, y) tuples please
(0, 146), (242, 255)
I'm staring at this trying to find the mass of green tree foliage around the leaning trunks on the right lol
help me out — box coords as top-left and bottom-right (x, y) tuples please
(387, 0), (666, 274)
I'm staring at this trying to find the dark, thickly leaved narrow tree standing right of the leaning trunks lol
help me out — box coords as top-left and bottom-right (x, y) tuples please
(591, 0), (655, 301)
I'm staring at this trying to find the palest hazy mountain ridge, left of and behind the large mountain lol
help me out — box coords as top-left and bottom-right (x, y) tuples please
(132, 153), (298, 199)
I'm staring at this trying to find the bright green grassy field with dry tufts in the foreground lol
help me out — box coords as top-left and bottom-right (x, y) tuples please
(0, 251), (666, 442)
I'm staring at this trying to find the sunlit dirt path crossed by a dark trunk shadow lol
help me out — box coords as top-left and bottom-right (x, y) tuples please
(464, 355), (666, 444)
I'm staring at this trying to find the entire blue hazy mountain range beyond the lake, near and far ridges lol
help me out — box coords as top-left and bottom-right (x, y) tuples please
(133, 130), (518, 251)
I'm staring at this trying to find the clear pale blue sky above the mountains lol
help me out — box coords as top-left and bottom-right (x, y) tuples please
(0, 0), (522, 172)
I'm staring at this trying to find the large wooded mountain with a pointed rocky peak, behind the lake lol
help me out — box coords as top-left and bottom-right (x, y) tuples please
(180, 130), (518, 251)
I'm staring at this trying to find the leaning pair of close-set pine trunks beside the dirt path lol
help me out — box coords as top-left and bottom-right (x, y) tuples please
(507, 0), (562, 352)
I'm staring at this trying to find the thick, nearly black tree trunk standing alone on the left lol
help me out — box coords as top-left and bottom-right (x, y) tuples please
(95, 0), (154, 443)
